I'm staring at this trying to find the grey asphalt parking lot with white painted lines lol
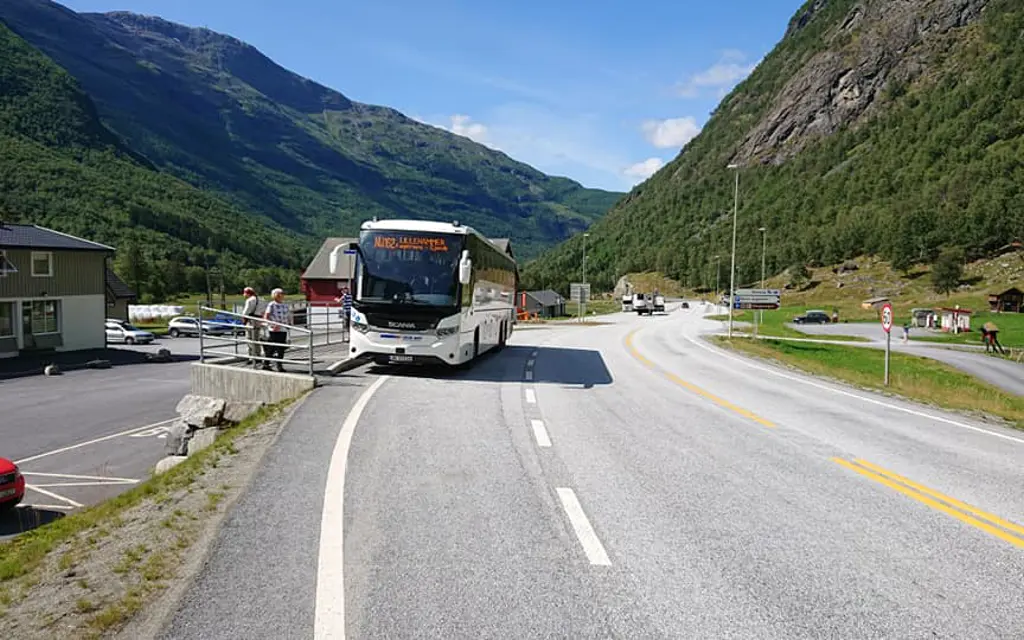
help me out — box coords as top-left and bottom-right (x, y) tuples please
(0, 339), (198, 516)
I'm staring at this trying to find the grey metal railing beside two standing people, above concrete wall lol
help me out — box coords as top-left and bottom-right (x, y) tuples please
(198, 306), (314, 376)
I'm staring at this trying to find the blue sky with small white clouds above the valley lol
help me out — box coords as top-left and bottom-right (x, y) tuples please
(62, 0), (803, 190)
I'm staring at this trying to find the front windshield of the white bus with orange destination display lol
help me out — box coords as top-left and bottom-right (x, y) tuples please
(356, 230), (464, 306)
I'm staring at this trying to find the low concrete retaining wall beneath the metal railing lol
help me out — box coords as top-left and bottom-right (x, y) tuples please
(189, 362), (316, 404)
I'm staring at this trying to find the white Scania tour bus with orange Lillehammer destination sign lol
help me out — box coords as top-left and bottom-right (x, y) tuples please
(330, 219), (518, 366)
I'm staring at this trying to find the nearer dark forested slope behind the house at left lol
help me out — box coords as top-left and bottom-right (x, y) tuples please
(0, 19), (309, 294)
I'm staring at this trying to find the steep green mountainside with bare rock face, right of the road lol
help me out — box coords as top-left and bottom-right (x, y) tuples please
(525, 0), (1024, 290)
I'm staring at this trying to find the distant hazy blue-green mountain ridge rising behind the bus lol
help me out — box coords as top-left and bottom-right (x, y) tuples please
(0, 0), (622, 257)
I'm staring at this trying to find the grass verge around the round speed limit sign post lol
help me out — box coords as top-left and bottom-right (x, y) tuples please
(715, 338), (1024, 429)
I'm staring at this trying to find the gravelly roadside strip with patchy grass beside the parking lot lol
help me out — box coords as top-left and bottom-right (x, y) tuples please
(0, 395), (307, 640)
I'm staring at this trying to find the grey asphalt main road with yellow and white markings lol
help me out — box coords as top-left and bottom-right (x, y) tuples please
(163, 309), (1024, 639)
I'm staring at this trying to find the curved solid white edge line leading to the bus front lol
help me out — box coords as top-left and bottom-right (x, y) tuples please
(313, 376), (389, 640)
